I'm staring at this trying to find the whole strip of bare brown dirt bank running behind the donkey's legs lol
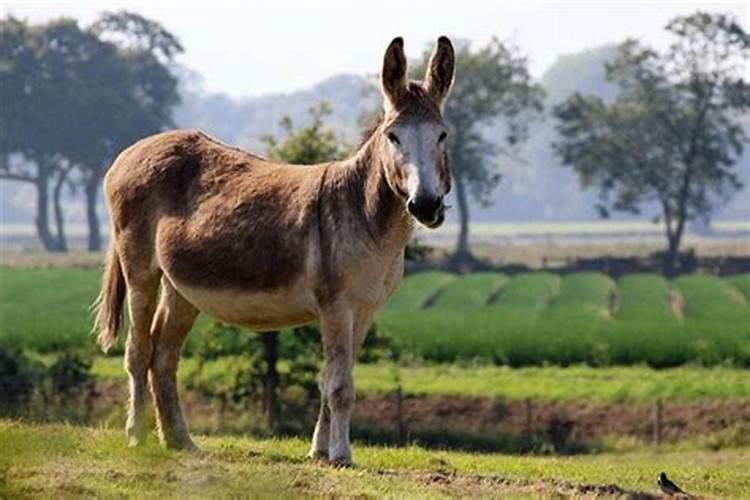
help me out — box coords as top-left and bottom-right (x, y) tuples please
(94, 381), (750, 447)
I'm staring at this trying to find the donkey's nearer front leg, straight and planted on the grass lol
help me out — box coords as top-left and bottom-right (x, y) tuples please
(312, 307), (354, 466)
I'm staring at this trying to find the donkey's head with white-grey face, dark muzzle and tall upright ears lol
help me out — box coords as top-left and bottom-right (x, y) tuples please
(376, 36), (455, 228)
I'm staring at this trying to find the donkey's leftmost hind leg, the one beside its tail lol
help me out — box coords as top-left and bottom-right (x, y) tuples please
(125, 267), (159, 446)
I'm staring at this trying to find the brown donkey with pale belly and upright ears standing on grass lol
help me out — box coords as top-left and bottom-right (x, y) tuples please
(94, 37), (455, 466)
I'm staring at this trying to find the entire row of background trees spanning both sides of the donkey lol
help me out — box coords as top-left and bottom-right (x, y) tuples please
(0, 12), (750, 270)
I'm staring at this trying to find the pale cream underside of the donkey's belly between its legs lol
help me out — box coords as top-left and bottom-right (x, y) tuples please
(174, 283), (317, 331)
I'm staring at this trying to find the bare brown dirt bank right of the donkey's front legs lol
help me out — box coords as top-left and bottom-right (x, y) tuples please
(353, 396), (750, 442)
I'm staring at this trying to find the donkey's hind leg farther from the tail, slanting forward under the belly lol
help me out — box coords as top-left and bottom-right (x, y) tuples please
(151, 276), (198, 450)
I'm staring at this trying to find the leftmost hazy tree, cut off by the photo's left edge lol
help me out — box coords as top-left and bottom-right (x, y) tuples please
(0, 18), (104, 251)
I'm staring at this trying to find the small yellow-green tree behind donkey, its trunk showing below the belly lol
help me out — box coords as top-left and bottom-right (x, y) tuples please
(261, 102), (346, 429)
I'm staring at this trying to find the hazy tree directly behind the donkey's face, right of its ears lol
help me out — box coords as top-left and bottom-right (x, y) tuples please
(413, 39), (544, 263)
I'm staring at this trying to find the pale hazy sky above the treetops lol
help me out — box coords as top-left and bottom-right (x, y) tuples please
(0, 0), (750, 96)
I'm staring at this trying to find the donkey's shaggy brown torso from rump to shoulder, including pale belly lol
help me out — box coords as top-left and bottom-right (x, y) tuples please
(105, 130), (323, 329)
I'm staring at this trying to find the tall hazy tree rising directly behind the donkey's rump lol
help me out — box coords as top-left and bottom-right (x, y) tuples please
(77, 11), (183, 250)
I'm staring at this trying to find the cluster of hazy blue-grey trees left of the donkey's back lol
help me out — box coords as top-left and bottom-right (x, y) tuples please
(0, 12), (183, 251)
